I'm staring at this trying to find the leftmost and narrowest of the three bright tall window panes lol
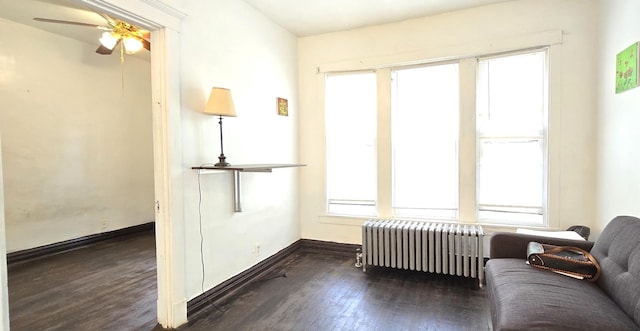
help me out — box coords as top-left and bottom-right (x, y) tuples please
(325, 72), (377, 216)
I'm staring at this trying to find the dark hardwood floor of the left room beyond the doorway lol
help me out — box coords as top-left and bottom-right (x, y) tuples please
(8, 232), (157, 331)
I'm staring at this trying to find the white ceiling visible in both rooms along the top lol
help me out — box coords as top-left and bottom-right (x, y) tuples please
(0, 0), (513, 47)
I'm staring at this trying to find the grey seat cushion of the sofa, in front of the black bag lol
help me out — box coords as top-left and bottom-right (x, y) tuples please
(485, 259), (638, 330)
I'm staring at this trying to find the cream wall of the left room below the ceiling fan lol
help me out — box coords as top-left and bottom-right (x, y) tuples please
(0, 20), (154, 252)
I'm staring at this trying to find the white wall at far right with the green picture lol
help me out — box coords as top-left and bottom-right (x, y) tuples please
(597, 0), (640, 230)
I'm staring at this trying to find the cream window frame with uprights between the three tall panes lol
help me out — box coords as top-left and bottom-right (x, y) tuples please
(318, 35), (563, 228)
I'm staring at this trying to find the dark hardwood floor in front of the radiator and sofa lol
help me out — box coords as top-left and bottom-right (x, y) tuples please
(179, 251), (491, 331)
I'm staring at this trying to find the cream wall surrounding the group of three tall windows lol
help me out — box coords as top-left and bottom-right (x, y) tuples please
(298, 0), (598, 243)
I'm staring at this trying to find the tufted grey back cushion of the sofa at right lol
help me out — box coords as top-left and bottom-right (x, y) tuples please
(591, 216), (640, 325)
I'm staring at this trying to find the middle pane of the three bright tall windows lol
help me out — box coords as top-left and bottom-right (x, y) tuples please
(391, 63), (459, 219)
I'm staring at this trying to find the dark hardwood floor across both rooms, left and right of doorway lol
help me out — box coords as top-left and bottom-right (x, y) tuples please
(9, 234), (490, 331)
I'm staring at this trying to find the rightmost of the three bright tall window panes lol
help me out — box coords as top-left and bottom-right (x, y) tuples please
(476, 50), (548, 225)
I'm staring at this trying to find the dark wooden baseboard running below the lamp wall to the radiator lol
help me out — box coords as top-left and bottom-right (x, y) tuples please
(187, 239), (360, 320)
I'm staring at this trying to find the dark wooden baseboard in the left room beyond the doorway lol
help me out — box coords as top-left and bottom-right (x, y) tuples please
(7, 222), (155, 266)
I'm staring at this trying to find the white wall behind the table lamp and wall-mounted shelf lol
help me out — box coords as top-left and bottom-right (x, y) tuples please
(180, 0), (300, 300)
